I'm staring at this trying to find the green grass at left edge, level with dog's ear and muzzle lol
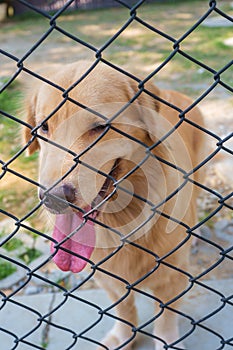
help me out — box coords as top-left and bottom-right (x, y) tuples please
(0, 77), (38, 223)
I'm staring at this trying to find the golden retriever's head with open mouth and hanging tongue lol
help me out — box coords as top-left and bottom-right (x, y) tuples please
(25, 63), (191, 272)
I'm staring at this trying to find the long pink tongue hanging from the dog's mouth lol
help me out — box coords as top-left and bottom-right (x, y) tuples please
(51, 212), (95, 272)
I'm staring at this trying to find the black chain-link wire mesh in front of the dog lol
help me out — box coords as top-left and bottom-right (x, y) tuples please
(0, 0), (233, 350)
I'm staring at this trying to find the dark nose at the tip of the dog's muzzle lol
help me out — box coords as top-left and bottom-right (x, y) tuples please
(39, 184), (75, 214)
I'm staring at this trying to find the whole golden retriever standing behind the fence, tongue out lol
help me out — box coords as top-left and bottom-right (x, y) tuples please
(25, 62), (203, 350)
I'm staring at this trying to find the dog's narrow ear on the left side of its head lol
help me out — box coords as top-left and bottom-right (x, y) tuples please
(23, 93), (39, 155)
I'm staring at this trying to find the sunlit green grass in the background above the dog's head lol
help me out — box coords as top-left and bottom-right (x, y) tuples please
(2, 1), (232, 93)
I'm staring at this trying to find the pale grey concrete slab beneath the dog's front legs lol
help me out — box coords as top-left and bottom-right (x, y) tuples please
(0, 279), (233, 350)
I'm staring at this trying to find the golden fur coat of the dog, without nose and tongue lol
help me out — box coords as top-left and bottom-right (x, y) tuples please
(25, 62), (206, 350)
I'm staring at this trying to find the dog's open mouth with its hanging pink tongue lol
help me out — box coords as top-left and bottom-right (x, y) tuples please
(51, 159), (119, 272)
